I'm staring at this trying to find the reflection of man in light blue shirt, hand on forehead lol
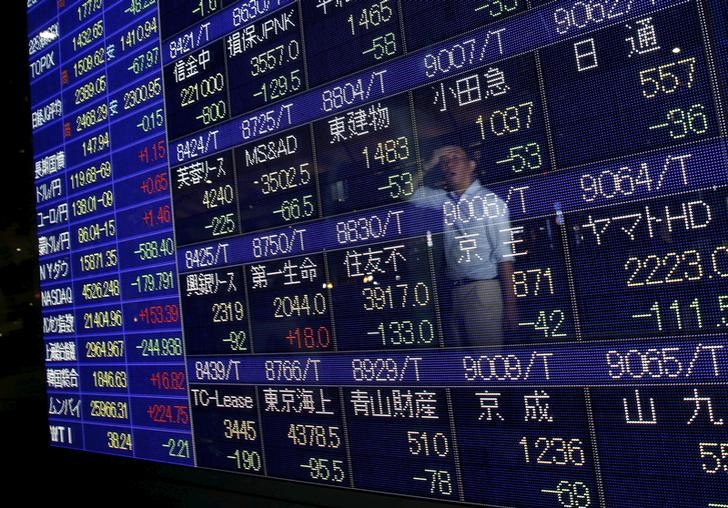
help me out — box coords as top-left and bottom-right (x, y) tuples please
(412, 146), (517, 346)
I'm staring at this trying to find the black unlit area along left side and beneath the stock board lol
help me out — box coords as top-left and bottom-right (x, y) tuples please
(0, 0), (444, 508)
